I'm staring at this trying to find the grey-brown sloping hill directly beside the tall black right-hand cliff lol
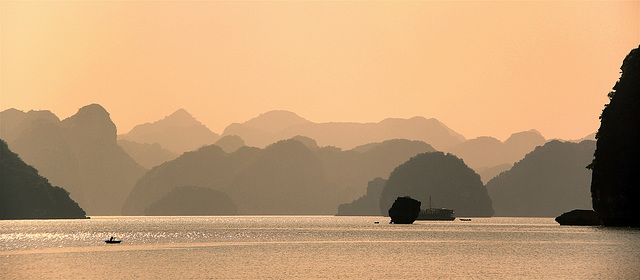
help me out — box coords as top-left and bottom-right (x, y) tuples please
(487, 140), (595, 217)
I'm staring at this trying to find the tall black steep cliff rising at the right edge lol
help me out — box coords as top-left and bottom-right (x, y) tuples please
(589, 44), (640, 227)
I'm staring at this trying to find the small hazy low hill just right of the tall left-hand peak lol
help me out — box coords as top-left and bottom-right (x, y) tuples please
(118, 139), (178, 169)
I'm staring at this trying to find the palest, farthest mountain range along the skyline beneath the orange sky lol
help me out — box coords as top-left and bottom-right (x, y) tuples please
(120, 109), (546, 175)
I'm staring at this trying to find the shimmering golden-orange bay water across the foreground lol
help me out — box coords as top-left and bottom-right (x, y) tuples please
(0, 216), (640, 279)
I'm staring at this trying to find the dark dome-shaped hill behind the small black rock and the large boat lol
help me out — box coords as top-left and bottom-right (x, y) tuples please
(380, 152), (494, 217)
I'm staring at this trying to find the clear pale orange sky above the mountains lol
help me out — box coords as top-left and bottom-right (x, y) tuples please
(0, 0), (640, 140)
